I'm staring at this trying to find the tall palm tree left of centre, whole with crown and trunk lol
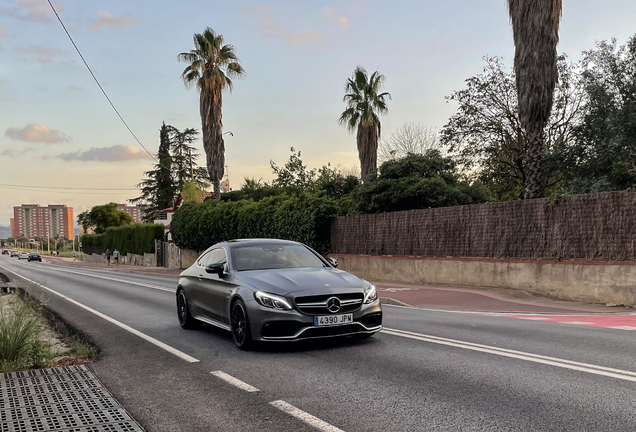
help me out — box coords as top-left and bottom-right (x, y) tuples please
(177, 27), (245, 199)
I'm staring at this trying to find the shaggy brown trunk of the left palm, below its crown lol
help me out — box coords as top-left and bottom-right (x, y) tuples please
(199, 83), (225, 200)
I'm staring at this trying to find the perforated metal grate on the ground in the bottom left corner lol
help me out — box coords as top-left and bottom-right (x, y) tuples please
(0, 366), (143, 432)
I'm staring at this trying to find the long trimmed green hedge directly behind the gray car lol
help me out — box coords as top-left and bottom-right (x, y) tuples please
(170, 194), (337, 254)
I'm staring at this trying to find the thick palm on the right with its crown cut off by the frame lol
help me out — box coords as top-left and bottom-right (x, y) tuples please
(508, 0), (561, 199)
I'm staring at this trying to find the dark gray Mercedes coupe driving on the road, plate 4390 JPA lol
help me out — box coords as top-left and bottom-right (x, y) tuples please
(177, 239), (382, 349)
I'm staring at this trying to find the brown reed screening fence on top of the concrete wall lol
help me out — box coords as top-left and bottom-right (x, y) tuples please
(331, 191), (636, 260)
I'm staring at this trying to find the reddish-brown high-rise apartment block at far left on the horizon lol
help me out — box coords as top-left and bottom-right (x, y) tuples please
(11, 204), (73, 239)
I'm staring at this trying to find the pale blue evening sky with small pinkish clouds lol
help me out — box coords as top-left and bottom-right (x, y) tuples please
(0, 0), (636, 225)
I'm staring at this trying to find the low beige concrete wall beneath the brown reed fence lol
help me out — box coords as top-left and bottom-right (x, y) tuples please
(331, 254), (636, 307)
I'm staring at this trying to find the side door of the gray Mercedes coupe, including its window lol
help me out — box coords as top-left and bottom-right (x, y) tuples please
(198, 247), (233, 323)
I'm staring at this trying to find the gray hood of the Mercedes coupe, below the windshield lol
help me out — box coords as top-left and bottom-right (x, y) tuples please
(234, 267), (368, 295)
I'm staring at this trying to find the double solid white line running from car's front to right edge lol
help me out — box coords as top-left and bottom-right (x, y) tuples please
(382, 328), (636, 382)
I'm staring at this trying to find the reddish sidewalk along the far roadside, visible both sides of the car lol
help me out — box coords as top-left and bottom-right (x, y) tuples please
(44, 256), (634, 314)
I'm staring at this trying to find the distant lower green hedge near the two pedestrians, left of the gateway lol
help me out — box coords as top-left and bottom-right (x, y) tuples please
(82, 224), (164, 255)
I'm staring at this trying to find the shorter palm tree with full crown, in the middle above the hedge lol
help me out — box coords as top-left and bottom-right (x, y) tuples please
(340, 66), (391, 181)
